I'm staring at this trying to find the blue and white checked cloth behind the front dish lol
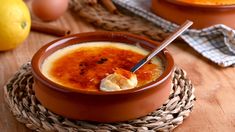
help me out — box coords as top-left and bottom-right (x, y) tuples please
(113, 0), (235, 67)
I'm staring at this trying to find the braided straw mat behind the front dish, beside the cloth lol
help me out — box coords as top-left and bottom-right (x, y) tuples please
(70, 0), (169, 41)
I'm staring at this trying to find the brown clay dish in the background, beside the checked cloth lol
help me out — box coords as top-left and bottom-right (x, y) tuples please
(151, 0), (235, 29)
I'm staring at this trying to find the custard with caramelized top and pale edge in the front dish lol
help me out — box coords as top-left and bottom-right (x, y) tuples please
(41, 42), (164, 91)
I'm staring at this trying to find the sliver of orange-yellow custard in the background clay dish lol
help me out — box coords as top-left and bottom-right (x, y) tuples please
(176, 0), (235, 5)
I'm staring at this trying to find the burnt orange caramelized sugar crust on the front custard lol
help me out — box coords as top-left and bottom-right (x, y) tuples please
(44, 47), (163, 91)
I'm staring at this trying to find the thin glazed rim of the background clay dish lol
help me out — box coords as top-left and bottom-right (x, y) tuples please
(166, 0), (235, 9)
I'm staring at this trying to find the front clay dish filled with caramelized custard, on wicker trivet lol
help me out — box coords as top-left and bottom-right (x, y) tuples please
(32, 32), (174, 122)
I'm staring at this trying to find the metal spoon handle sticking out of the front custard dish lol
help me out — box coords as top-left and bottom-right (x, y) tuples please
(131, 20), (193, 73)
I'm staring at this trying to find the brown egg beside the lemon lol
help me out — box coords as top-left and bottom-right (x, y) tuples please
(32, 0), (69, 21)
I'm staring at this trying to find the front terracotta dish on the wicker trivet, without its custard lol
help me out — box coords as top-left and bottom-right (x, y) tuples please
(32, 32), (174, 122)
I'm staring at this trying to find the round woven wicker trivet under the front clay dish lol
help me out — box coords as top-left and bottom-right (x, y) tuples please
(4, 63), (195, 132)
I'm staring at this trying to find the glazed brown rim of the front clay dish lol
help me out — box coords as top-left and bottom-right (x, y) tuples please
(31, 31), (174, 95)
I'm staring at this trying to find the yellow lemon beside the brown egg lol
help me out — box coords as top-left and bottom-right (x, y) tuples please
(0, 0), (31, 51)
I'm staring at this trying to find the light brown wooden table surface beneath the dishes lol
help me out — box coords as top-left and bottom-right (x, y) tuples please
(0, 9), (235, 132)
